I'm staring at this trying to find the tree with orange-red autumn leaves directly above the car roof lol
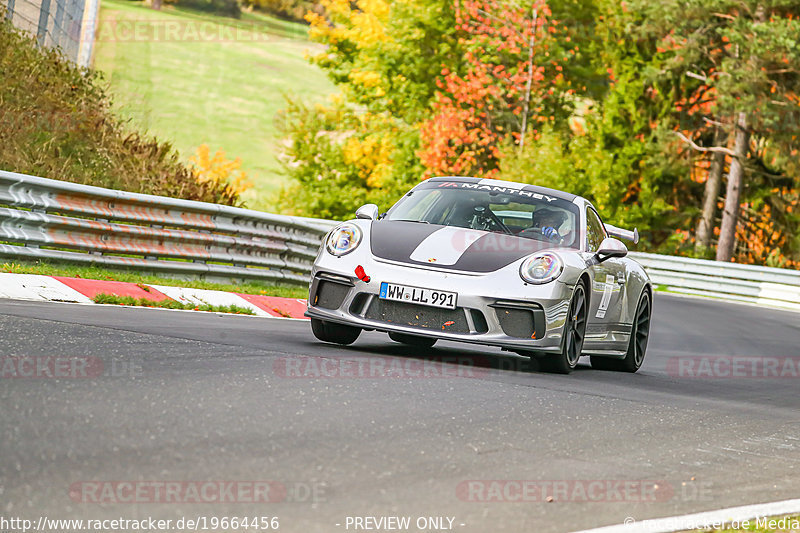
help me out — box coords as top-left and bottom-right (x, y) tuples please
(419, 0), (575, 177)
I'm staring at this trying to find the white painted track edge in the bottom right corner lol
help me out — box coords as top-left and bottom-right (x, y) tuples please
(574, 499), (800, 533)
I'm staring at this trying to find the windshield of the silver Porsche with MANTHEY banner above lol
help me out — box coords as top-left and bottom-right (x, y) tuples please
(386, 182), (579, 248)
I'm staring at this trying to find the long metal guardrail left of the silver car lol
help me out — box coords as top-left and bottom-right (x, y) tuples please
(0, 171), (333, 283)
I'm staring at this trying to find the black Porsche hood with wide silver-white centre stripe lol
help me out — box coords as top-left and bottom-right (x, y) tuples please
(370, 220), (553, 272)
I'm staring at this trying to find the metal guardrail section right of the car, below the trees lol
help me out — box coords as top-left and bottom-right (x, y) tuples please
(629, 252), (800, 310)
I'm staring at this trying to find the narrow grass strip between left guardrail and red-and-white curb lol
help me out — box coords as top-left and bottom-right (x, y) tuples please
(0, 262), (308, 298)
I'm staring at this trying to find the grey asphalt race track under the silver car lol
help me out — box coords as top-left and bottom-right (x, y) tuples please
(0, 294), (800, 532)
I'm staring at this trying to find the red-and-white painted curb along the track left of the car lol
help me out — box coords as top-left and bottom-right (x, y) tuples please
(0, 272), (306, 318)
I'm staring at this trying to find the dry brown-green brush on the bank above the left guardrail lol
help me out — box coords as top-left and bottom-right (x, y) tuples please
(0, 11), (240, 205)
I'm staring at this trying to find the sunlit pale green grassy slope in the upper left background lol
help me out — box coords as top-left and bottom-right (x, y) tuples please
(94, 0), (334, 209)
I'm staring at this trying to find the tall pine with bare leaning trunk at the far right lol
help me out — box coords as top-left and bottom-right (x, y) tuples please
(632, 0), (800, 261)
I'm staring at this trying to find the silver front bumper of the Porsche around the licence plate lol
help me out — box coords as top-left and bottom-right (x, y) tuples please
(306, 249), (574, 353)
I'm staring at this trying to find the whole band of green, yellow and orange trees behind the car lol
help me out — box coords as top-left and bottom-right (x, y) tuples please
(281, 0), (800, 267)
